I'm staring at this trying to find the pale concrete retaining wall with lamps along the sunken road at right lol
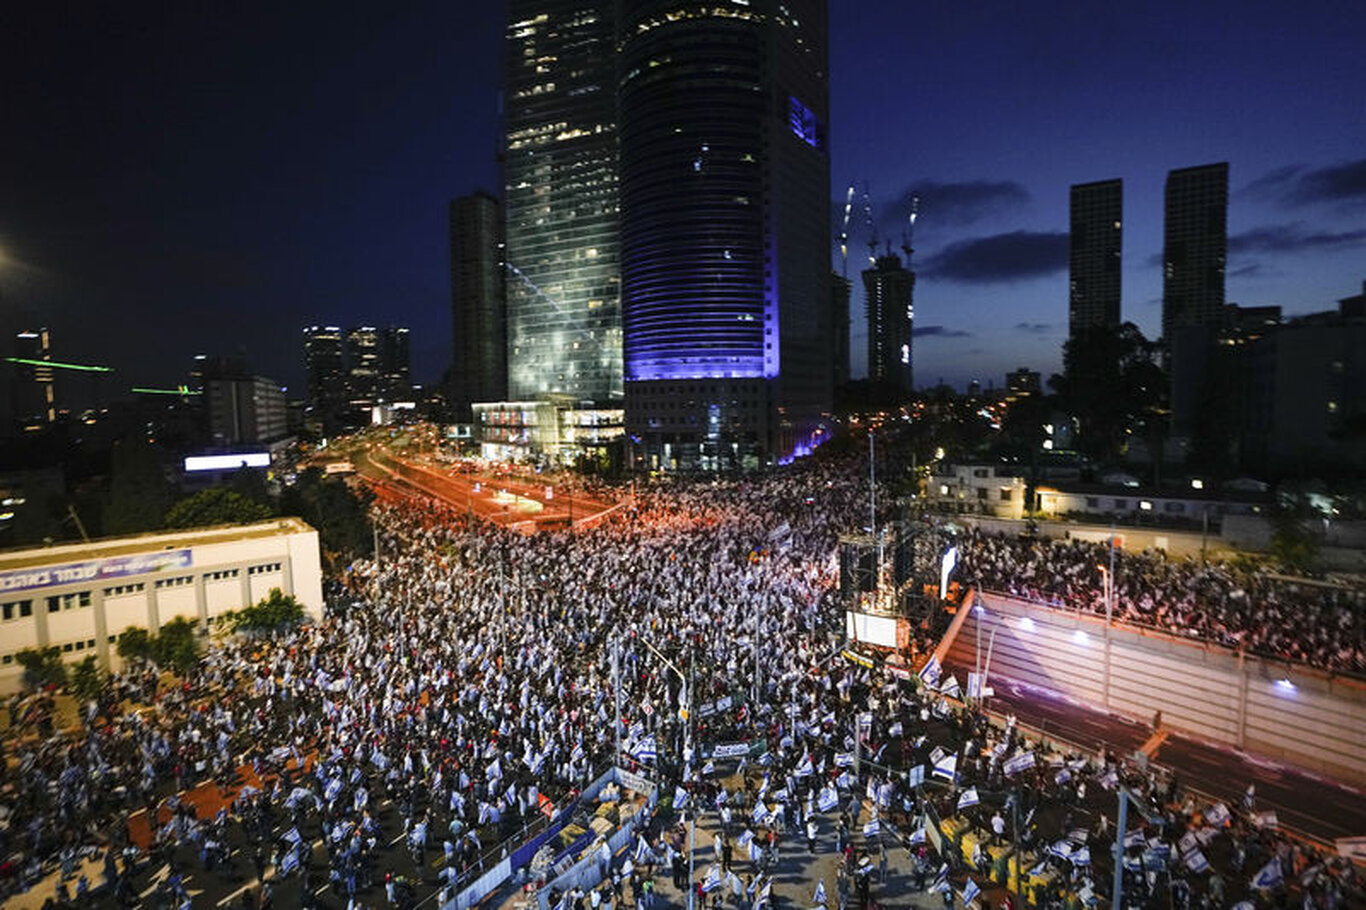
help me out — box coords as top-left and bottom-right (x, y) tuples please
(949, 594), (1366, 784)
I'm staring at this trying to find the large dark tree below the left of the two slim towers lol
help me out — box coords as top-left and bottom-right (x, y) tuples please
(1049, 322), (1168, 459)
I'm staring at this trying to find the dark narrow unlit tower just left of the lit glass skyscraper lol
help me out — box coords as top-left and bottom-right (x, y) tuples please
(451, 193), (508, 421)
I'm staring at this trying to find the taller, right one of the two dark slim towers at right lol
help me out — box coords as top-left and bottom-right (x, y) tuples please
(1162, 161), (1228, 338)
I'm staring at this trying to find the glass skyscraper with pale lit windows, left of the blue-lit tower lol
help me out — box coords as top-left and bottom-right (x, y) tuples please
(503, 0), (622, 402)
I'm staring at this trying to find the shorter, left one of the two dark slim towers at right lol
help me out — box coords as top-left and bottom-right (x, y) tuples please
(1067, 180), (1124, 339)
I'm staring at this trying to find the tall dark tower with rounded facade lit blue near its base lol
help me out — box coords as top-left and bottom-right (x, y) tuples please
(617, 0), (835, 470)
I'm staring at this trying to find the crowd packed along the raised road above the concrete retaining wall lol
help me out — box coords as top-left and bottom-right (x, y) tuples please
(959, 529), (1366, 675)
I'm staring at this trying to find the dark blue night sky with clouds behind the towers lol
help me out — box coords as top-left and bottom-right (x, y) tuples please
(0, 0), (1366, 399)
